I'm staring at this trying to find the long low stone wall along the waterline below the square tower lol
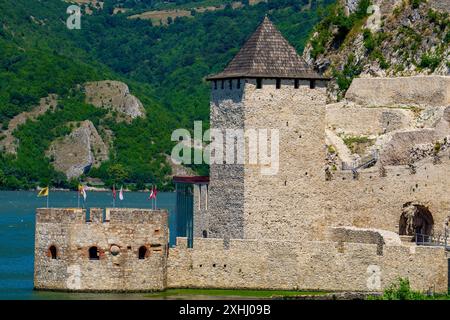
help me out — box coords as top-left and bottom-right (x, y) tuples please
(167, 238), (447, 292)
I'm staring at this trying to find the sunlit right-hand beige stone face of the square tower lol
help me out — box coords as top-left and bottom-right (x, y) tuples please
(244, 80), (326, 241)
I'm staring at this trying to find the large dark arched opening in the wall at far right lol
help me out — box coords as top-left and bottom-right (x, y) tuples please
(399, 202), (434, 237)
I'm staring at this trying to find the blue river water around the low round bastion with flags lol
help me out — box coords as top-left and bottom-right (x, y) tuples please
(0, 191), (176, 299)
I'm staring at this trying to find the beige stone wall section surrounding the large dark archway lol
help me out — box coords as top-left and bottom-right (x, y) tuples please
(320, 155), (450, 239)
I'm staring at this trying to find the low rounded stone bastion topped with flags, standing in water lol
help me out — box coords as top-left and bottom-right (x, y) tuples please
(34, 209), (168, 291)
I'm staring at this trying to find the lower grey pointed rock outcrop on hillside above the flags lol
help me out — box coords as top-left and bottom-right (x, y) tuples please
(46, 120), (109, 179)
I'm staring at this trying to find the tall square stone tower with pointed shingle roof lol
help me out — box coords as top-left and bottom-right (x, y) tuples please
(206, 17), (328, 240)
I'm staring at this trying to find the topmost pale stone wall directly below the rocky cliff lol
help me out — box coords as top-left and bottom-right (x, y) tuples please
(345, 76), (450, 106)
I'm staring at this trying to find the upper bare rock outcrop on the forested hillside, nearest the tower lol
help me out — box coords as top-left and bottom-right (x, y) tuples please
(84, 80), (145, 121)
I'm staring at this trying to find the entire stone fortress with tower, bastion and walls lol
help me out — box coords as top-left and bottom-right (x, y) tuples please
(35, 18), (450, 292)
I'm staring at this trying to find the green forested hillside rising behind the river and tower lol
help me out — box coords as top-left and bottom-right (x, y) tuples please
(0, 0), (333, 189)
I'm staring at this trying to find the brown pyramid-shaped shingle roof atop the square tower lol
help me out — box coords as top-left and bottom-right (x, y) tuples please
(206, 17), (325, 80)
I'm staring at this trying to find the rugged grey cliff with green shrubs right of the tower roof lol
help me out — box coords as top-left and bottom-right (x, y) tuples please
(304, 0), (450, 100)
